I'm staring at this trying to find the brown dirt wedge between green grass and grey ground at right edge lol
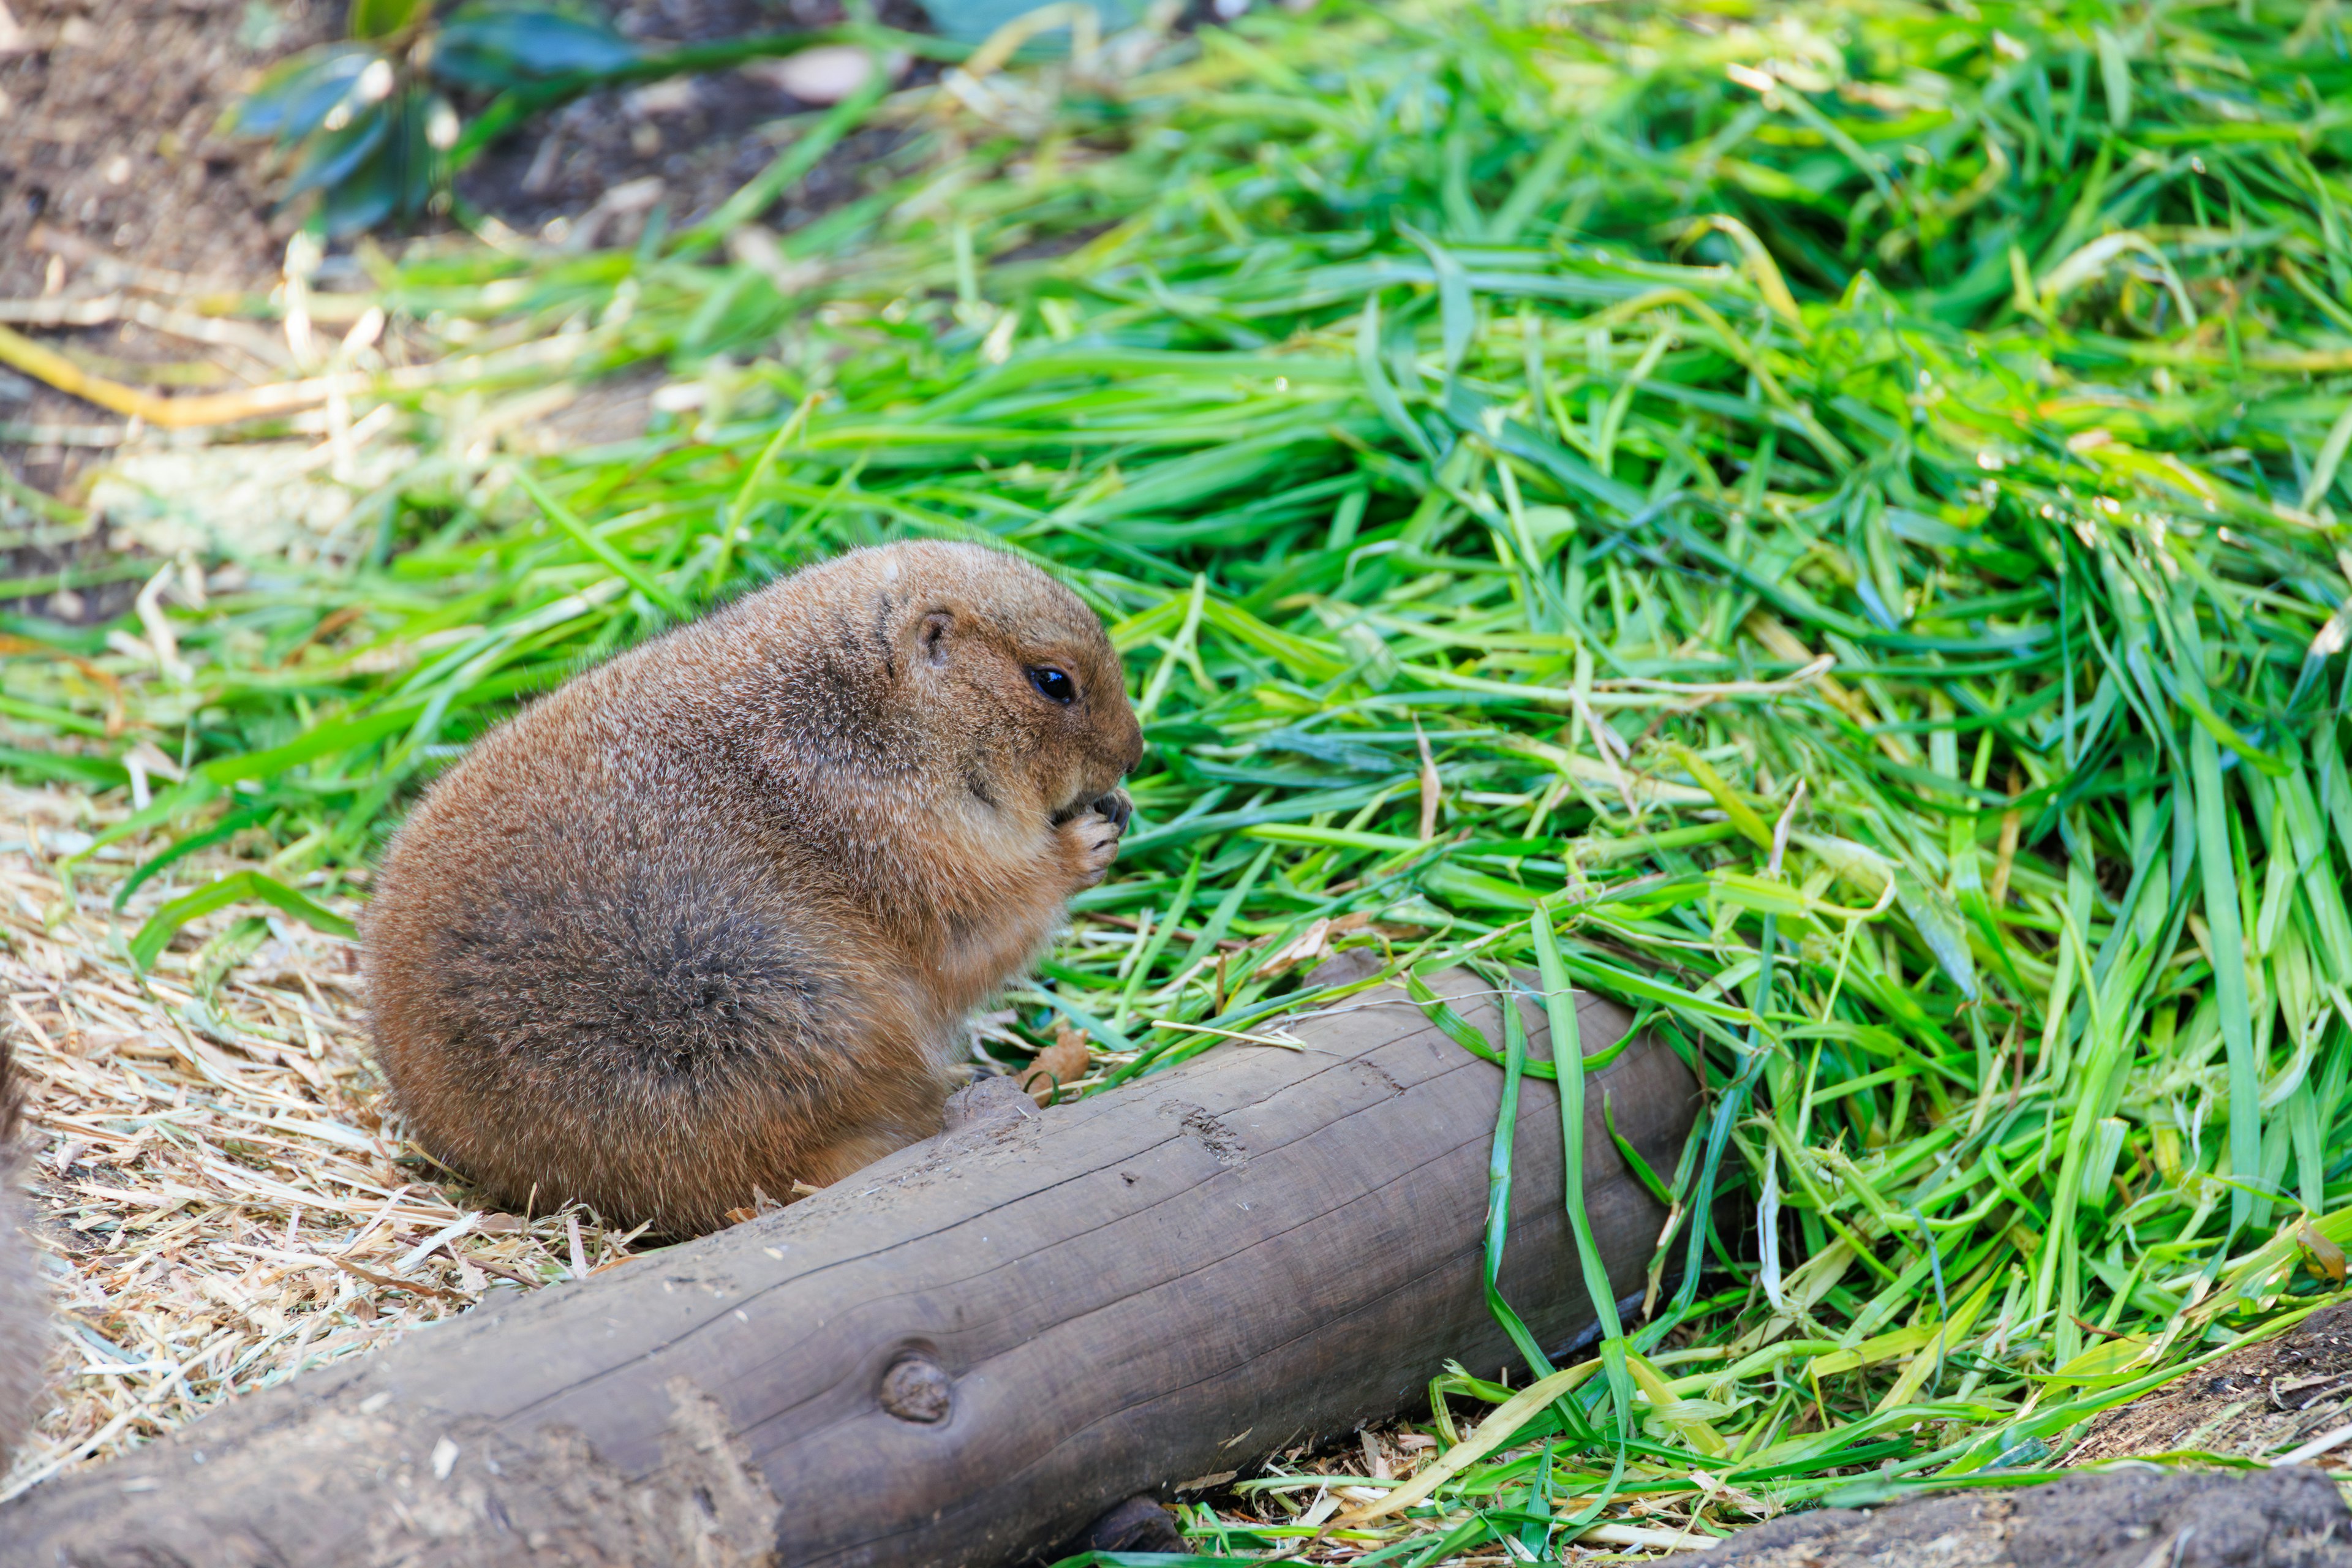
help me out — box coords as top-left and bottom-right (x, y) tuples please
(2065, 1305), (2352, 1464)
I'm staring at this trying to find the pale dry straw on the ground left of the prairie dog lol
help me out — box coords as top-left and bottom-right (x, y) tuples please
(0, 785), (638, 1500)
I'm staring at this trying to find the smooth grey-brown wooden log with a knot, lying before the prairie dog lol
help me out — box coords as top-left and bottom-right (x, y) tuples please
(0, 976), (1696, 1568)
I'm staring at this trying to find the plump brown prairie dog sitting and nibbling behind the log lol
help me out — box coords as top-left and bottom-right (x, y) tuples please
(364, 543), (1143, 1234)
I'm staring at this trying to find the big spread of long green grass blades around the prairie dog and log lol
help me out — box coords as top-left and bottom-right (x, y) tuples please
(5, 0), (2352, 1563)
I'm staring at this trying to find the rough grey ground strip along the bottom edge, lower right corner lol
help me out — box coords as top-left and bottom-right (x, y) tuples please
(1708, 1464), (2352, 1568)
